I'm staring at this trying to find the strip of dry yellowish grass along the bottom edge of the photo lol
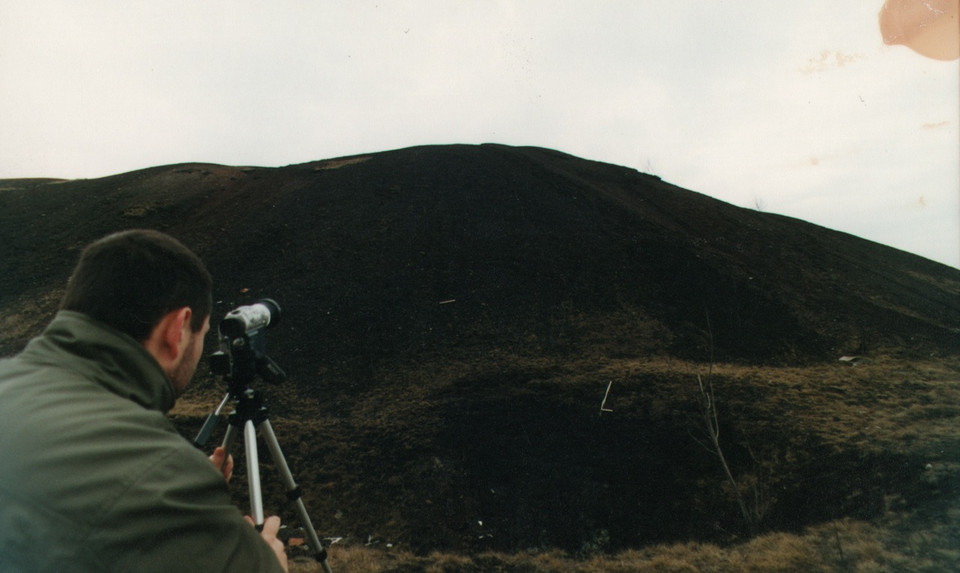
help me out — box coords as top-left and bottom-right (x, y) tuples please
(290, 519), (960, 573)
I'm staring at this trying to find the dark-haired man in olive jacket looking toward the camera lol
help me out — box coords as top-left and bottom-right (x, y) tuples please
(0, 230), (286, 573)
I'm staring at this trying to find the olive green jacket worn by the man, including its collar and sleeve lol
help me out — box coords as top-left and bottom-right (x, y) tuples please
(0, 312), (281, 573)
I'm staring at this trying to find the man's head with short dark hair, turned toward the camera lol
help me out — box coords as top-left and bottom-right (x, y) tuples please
(60, 230), (212, 393)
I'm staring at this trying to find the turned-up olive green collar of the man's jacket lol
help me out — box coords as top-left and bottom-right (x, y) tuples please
(24, 311), (176, 413)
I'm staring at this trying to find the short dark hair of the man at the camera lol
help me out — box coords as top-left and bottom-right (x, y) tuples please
(60, 229), (212, 342)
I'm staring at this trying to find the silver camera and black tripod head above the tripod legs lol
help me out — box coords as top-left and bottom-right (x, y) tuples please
(210, 298), (287, 397)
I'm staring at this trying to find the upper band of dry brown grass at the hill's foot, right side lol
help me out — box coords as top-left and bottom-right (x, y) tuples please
(597, 356), (960, 452)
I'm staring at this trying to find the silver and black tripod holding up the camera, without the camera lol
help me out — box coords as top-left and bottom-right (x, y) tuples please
(193, 330), (332, 573)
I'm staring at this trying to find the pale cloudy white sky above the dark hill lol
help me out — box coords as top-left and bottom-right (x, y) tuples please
(0, 0), (960, 267)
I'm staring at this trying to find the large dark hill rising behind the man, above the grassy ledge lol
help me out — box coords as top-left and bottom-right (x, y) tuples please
(0, 145), (960, 364)
